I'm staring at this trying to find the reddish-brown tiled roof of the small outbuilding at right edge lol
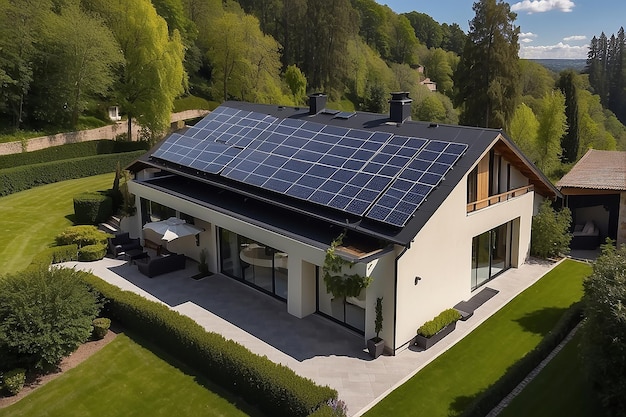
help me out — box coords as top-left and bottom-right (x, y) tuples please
(556, 149), (626, 191)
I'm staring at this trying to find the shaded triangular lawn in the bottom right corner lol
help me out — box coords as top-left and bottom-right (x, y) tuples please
(500, 331), (603, 417)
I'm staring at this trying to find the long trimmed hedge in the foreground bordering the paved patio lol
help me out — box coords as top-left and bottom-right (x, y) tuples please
(83, 272), (337, 417)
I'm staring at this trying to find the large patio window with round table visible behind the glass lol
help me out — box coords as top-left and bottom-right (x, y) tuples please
(220, 229), (288, 300)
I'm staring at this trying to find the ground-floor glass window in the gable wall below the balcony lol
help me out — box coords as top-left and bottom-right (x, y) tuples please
(472, 222), (513, 290)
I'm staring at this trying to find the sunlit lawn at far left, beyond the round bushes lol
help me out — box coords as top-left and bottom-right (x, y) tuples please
(0, 174), (114, 274)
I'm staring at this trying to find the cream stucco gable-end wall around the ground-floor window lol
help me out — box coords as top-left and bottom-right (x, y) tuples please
(395, 172), (534, 349)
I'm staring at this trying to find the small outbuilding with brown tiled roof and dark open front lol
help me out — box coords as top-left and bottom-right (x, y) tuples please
(556, 149), (626, 249)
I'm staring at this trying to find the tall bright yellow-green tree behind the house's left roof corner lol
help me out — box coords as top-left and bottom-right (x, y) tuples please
(85, 0), (185, 138)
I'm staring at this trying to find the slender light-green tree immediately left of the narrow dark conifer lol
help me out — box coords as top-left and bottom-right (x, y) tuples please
(537, 90), (567, 175)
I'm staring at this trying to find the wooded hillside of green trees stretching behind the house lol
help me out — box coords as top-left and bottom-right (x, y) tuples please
(0, 0), (626, 178)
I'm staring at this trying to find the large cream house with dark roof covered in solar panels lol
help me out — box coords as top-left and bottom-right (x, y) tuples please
(125, 93), (559, 353)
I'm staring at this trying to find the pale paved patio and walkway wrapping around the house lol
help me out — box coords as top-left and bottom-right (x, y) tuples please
(66, 258), (556, 416)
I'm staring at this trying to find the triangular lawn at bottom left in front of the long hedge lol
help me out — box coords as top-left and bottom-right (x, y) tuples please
(0, 334), (260, 417)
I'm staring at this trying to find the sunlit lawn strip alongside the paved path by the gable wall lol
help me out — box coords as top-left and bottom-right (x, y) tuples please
(366, 260), (591, 417)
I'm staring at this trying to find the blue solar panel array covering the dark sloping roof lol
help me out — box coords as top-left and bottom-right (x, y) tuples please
(152, 106), (467, 227)
